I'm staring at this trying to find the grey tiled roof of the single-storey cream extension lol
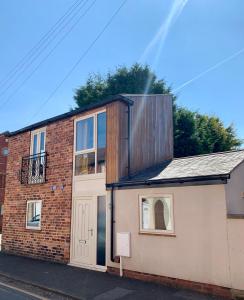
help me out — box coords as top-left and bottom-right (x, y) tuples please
(111, 149), (244, 185)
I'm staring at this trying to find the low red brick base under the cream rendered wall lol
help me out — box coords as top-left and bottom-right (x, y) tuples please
(107, 267), (233, 299)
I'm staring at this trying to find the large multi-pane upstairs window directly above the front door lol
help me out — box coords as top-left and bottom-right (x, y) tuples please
(75, 112), (106, 176)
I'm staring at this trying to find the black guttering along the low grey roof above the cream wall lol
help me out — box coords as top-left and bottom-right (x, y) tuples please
(106, 174), (230, 189)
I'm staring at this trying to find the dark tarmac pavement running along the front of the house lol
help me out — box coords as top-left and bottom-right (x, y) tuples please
(0, 252), (221, 300)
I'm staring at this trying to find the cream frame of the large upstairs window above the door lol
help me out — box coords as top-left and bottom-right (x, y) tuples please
(73, 109), (107, 179)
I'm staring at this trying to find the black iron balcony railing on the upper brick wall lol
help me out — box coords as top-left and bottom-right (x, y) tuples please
(20, 152), (47, 184)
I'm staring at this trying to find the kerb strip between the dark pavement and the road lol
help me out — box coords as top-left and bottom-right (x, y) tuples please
(0, 272), (81, 300)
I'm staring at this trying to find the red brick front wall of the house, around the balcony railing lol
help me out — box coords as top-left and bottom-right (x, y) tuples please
(2, 108), (104, 263)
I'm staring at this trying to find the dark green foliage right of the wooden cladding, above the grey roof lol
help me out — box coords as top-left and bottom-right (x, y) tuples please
(174, 107), (241, 157)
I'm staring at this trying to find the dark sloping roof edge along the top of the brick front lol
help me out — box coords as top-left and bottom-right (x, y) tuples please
(6, 94), (134, 137)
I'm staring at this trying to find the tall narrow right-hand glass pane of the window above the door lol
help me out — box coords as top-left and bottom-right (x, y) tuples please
(97, 112), (106, 173)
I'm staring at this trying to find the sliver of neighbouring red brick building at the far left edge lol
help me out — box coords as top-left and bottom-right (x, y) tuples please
(0, 134), (8, 232)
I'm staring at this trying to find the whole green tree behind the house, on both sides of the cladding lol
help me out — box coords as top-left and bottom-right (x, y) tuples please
(74, 64), (242, 157)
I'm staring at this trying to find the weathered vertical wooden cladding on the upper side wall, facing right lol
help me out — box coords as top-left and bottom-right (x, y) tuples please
(128, 95), (173, 173)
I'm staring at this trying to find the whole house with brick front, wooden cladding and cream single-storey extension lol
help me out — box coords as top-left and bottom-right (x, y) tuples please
(2, 95), (244, 296)
